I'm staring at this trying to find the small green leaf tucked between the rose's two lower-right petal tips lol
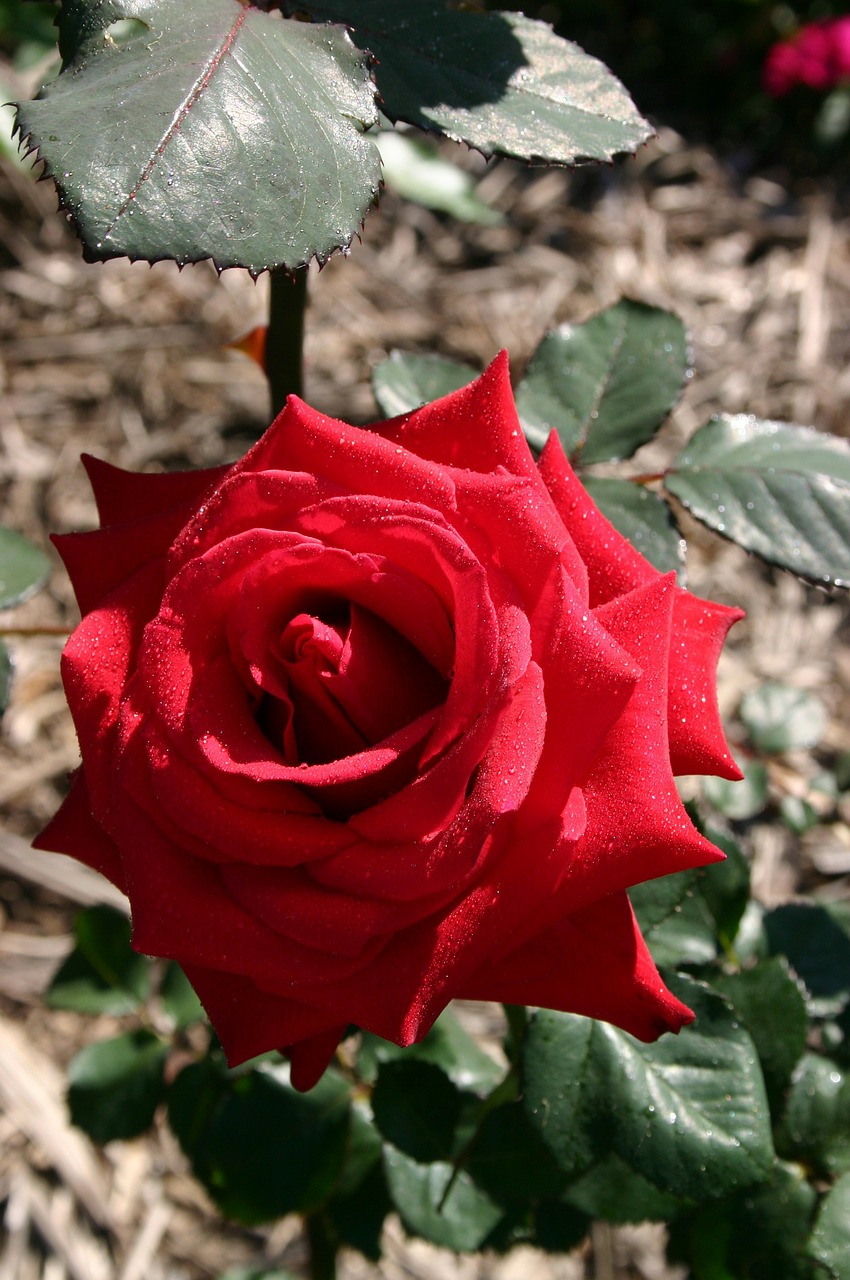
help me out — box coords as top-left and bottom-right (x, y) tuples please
(629, 870), (717, 965)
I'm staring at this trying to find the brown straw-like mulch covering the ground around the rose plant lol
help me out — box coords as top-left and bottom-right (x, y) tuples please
(0, 122), (850, 1280)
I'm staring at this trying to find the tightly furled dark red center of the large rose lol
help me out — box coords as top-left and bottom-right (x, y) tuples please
(260, 593), (448, 764)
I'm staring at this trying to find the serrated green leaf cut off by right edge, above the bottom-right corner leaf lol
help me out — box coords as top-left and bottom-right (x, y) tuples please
(776, 1053), (850, 1175)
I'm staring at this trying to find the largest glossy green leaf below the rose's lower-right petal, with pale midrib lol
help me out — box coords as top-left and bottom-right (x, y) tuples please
(522, 974), (773, 1201)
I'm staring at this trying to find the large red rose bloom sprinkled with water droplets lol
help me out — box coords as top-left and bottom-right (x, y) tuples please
(38, 356), (741, 1088)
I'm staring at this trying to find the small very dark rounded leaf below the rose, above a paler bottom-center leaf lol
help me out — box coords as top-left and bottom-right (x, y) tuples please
(371, 1059), (463, 1162)
